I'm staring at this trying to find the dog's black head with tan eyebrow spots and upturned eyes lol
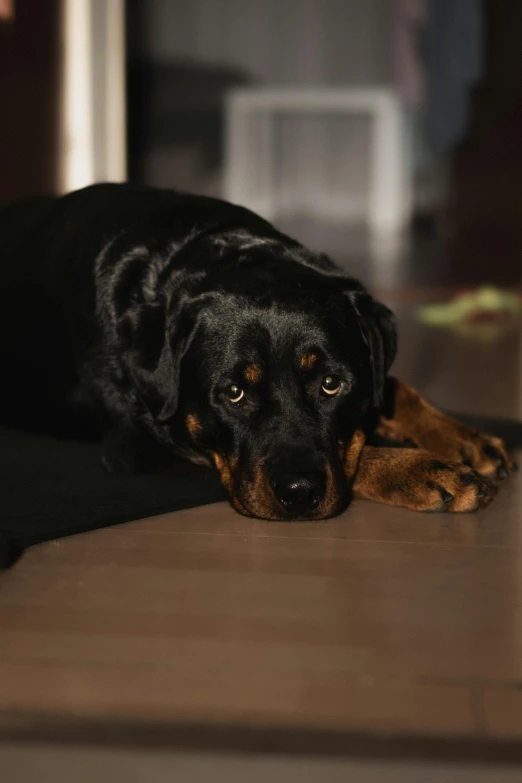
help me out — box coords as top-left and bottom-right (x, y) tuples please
(118, 234), (395, 519)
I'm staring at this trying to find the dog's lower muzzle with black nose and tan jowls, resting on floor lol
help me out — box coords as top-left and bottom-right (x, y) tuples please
(209, 454), (351, 521)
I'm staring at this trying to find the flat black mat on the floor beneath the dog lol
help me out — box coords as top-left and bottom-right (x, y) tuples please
(0, 415), (522, 568)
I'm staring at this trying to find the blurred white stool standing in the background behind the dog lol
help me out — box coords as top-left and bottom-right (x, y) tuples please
(225, 87), (412, 236)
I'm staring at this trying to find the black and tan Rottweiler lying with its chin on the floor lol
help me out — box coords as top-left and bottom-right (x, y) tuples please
(0, 184), (512, 520)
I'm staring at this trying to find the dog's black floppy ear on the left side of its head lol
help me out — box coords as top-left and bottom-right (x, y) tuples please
(119, 301), (187, 424)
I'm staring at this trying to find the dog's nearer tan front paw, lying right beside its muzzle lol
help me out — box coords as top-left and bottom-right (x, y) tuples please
(353, 446), (497, 511)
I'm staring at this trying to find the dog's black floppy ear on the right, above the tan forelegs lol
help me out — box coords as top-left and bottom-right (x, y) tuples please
(349, 292), (397, 408)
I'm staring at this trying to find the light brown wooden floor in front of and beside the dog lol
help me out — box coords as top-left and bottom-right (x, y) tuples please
(0, 307), (522, 772)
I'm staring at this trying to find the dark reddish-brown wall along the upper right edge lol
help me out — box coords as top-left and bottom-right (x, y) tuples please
(450, 0), (522, 286)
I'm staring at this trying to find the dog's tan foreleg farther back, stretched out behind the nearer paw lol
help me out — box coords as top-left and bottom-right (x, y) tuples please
(376, 378), (514, 478)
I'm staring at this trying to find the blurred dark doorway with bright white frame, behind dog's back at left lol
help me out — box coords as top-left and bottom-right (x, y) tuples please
(0, 0), (126, 205)
